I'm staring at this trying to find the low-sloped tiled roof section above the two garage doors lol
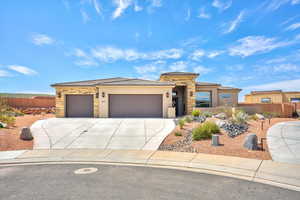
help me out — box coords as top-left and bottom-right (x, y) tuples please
(51, 77), (175, 87)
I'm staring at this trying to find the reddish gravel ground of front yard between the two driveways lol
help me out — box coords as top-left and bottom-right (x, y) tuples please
(160, 115), (297, 160)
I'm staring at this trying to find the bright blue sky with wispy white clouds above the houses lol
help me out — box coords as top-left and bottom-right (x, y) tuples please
(0, 0), (300, 100)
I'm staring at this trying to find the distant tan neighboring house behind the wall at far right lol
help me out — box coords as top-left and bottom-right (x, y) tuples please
(245, 90), (300, 103)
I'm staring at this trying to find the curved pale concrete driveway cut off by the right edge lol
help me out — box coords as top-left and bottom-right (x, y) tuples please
(267, 121), (300, 164)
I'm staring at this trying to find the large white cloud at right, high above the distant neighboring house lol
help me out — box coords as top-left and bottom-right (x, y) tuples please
(229, 36), (299, 57)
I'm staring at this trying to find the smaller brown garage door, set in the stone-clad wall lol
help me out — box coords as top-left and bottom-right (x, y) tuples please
(66, 95), (94, 117)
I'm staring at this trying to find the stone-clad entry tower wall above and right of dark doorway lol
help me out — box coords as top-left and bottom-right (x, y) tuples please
(160, 75), (197, 114)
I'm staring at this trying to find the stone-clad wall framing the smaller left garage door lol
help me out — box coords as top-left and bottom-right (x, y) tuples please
(55, 87), (99, 117)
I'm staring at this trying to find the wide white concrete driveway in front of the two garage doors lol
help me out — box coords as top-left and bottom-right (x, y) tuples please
(31, 118), (175, 150)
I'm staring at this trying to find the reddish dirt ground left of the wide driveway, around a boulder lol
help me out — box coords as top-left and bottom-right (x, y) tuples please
(0, 114), (54, 151)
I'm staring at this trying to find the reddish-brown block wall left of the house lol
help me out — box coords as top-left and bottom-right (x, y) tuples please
(0, 97), (55, 108)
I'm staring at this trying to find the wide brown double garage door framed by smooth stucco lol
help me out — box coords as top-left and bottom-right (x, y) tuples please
(109, 94), (162, 117)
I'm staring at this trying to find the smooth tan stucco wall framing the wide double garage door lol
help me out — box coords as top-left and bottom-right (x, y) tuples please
(99, 86), (173, 118)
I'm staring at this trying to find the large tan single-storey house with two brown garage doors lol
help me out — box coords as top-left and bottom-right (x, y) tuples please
(51, 72), (241, 117)
